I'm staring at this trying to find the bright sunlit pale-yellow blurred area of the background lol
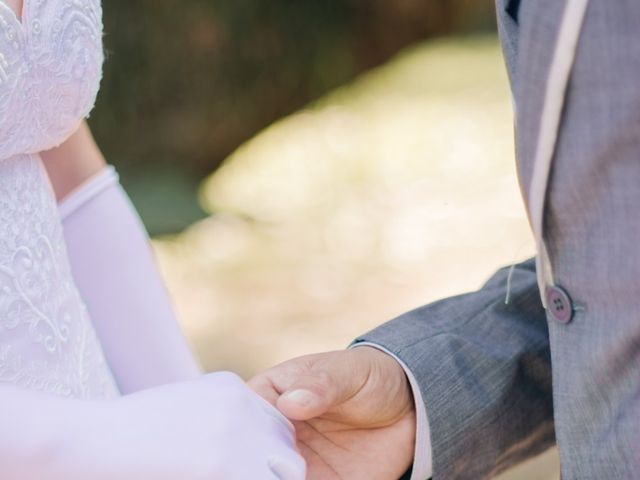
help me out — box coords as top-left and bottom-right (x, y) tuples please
(154, 32), (559, 480)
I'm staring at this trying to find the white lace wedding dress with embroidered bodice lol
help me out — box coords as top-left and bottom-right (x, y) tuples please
(0, 0), (118, 399)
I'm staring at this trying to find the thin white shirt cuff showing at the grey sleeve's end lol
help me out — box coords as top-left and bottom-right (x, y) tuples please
(351, 342), (433, 480)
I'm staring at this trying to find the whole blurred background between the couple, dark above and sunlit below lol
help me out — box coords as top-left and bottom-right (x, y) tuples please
(90, 0), (558, 480)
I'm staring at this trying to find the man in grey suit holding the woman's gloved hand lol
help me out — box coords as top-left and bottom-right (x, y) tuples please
(251, 0), (640, 480)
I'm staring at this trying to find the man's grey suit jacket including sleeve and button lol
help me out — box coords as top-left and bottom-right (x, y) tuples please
(357, 0), (640, 480)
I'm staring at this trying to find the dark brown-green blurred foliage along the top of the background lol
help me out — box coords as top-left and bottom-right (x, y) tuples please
(91, 0), (494, 175)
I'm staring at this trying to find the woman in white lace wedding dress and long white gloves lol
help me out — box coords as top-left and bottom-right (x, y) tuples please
(0, 0), (304, 480)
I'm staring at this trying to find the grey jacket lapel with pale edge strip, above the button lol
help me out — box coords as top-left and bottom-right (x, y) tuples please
(515, 0), (588, 298)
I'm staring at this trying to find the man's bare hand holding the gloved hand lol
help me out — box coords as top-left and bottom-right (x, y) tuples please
(249, 347), (416, 480)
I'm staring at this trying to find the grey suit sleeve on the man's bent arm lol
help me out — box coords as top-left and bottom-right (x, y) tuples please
(355, 259), (555, 480)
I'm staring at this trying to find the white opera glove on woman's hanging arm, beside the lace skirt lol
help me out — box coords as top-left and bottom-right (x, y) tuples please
(59, 167), (202, 394)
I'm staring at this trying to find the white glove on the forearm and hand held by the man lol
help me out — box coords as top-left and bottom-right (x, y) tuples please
(0, 373), (305, 480)
